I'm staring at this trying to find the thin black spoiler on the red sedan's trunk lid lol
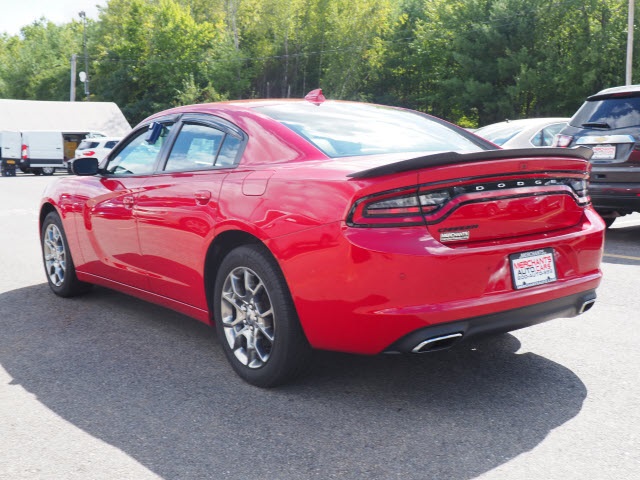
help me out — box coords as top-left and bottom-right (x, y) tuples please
(347, 147), (593, 178)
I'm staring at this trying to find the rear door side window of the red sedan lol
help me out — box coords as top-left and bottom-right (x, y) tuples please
(165, 123), (224, 171)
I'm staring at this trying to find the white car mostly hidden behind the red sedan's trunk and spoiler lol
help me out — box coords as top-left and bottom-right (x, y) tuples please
(473, 117), (569, 148)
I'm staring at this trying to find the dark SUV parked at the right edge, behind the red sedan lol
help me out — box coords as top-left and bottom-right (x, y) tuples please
(554, 85), (640, 226)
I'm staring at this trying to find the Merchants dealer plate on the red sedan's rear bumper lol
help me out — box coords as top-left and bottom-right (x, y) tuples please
(509, 248), (558, 290)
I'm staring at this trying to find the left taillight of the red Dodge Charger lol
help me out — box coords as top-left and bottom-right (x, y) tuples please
(347, 189), (451, 227)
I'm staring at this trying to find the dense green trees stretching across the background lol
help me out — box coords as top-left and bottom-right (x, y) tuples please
(0, 0), (640, 126)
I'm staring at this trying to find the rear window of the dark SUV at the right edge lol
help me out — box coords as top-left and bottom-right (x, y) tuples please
(569, 97), (640, 128)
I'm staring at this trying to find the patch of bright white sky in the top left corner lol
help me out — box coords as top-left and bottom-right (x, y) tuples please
(0, 0), (107, 35)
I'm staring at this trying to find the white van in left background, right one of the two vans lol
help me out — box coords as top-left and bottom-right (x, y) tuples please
(18, 131), (65, 175)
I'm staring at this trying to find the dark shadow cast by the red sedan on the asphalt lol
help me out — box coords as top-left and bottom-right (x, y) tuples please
(0, 285), (587, 480)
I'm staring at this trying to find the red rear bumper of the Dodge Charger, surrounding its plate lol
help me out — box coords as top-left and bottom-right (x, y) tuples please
(276, 209), (604, 354)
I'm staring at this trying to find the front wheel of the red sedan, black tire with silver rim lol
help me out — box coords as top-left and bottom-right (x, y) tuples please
(40, 212), (91, 297)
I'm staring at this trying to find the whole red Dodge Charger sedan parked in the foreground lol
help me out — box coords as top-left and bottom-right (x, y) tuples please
(40, 91), (604, 387)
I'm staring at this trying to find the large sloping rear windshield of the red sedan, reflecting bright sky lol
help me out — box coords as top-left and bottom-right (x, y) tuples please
(256, 102), (489, 157)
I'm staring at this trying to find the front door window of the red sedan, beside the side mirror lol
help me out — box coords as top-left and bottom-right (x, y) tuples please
(106, 124), (171, 175)
